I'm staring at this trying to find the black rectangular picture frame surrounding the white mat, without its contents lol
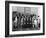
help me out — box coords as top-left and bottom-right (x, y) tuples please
(5, 1), (45, 37)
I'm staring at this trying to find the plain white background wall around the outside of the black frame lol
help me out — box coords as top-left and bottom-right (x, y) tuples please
(0, 0), (46, 38)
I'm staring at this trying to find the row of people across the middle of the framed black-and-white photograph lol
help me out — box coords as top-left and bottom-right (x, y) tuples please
(14, 15), (40, 28)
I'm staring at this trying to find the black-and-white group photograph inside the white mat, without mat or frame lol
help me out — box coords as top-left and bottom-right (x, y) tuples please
(12, 6), (41, 31)
